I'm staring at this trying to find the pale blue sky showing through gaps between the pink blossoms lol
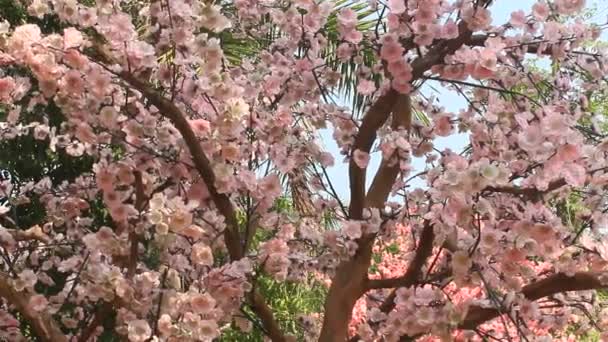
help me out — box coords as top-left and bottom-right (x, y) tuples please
(321, 0), (608, 202)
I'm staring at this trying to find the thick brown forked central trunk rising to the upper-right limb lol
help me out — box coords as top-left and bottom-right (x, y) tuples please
(320, 1), (489, 340)
